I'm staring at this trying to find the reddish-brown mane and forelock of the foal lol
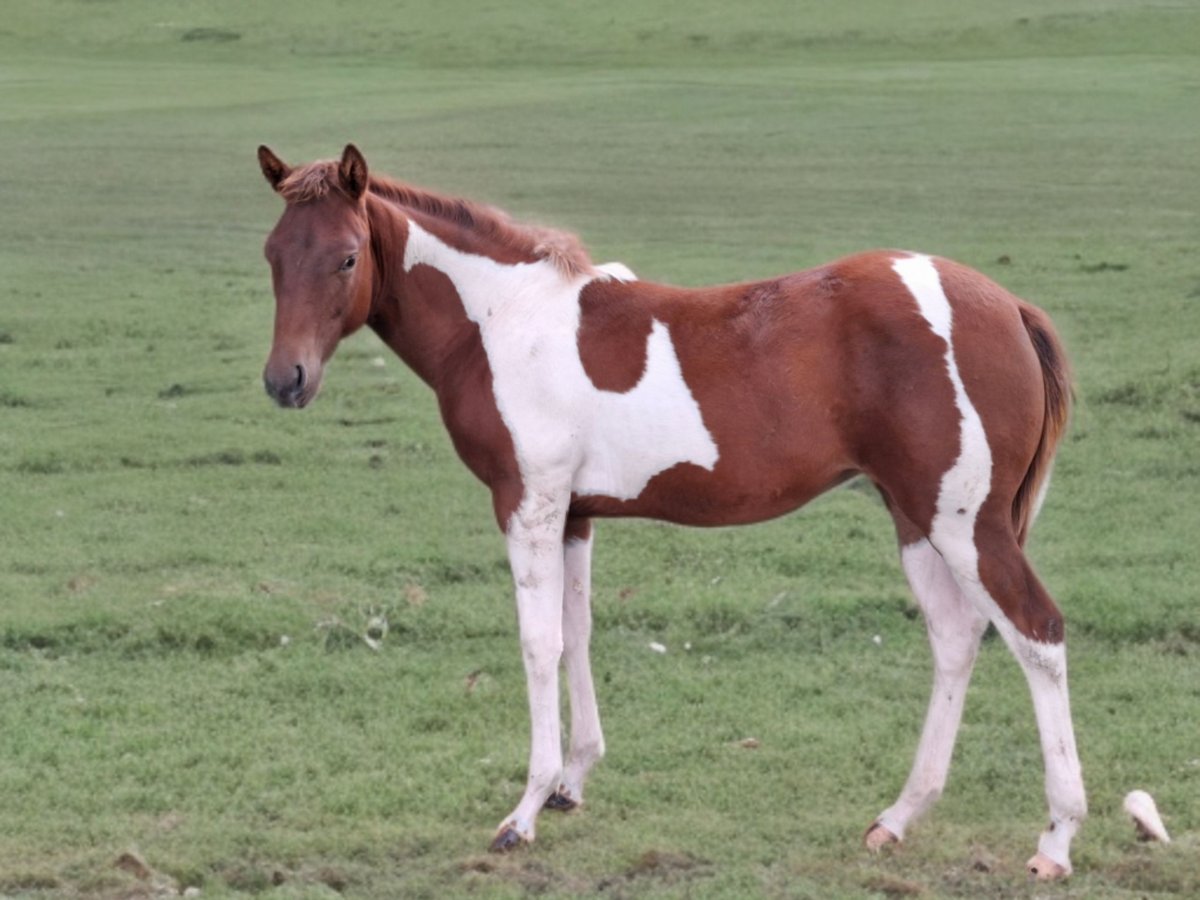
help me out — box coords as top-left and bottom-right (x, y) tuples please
(278, 160), (595, 278)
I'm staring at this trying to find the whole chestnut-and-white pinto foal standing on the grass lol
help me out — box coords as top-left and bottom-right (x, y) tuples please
(258, 144), (1087, 880)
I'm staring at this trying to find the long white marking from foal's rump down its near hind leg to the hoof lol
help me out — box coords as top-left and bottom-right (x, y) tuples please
(892, 256), (1087, 872)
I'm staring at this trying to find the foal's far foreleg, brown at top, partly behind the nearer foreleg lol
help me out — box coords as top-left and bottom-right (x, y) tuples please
(546, 520), (604, 811)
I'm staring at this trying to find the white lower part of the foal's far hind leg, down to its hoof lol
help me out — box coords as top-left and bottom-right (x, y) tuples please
(876, 540), (988, 840)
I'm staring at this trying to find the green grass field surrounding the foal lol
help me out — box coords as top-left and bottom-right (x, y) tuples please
(0, 0), (1200, 898)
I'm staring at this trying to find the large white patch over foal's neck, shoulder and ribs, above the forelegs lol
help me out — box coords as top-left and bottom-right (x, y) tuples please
(404, 221), (719, 500)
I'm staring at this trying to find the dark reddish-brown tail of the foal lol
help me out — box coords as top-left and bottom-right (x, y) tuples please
(1013, 302), (1074, 546)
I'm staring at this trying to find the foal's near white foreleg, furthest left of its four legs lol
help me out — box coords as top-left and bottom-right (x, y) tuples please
(492, 491), (569, 852)
